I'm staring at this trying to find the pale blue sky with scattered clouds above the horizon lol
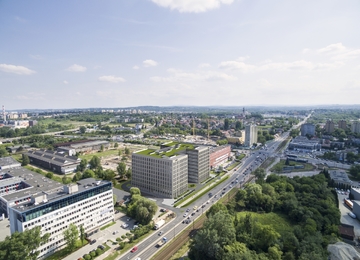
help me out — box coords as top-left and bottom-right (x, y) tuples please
(0, 0), (360, 110)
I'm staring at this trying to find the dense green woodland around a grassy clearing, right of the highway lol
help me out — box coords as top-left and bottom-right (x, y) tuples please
(189, 171), (340, 260)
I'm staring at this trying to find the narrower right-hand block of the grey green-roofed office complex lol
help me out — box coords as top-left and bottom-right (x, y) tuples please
(186, 146), (210, 183)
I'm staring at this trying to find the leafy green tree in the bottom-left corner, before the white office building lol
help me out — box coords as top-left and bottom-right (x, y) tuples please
(0, 226), (50, 260)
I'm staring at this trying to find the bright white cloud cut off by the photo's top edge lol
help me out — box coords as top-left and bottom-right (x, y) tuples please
(151, 0), (234, 13)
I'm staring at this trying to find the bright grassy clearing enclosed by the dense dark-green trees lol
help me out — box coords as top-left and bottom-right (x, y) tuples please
(237, 211), (293, 234)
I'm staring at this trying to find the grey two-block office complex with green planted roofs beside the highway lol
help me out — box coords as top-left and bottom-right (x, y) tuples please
(131, 144), (210, 198)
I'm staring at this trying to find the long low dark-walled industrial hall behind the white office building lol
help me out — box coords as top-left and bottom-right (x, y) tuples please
(26, 150), (81, 174)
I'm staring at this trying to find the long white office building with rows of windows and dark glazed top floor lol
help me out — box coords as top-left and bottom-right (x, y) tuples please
(9, 178), (114, 259)
